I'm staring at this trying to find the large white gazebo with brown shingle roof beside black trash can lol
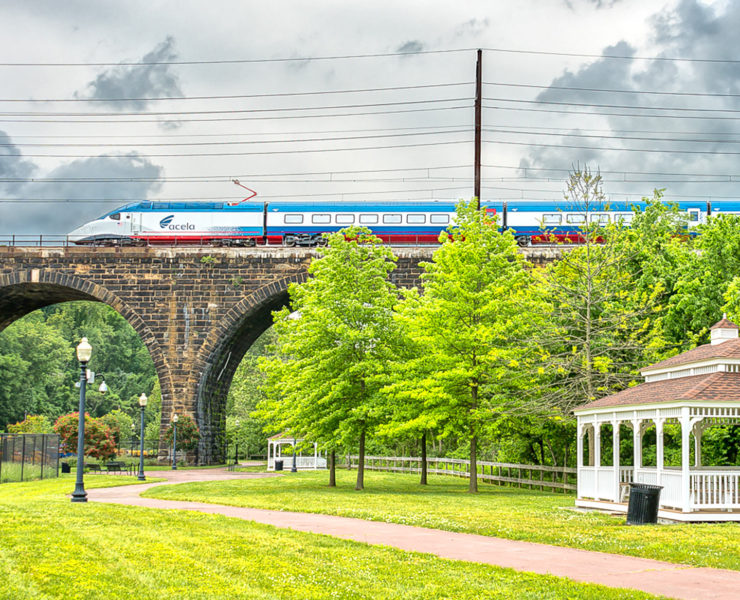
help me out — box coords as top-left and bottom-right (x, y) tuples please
(574, 318), (740, 521)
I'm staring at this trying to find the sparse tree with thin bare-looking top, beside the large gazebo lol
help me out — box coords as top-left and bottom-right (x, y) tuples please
(531, 169), (675, 418)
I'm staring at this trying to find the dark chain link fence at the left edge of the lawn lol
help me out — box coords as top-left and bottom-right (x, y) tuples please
(0, 433), (59, 483)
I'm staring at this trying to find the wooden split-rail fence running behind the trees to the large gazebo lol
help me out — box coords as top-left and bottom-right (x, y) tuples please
(347, 456), (576, 493)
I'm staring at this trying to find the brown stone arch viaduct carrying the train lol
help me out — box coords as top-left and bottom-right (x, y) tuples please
(0, 247), (555, 464)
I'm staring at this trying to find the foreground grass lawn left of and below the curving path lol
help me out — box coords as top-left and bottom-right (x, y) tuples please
(0, 475), (664, 600)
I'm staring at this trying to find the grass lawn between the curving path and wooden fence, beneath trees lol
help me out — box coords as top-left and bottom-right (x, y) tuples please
(145, 470), (740, 570)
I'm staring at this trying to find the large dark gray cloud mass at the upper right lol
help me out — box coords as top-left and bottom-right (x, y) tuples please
(520, 0), (740, 202)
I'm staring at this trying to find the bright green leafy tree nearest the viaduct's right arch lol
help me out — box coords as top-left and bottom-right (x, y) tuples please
(256, 228), (397, 490)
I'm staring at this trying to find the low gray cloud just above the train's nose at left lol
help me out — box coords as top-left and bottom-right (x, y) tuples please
(0, 153), (162, 235)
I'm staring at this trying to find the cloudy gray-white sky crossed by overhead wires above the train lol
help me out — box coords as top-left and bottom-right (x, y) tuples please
(0, 0), (740, 236)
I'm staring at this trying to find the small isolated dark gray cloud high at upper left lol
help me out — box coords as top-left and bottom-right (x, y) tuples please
(75, 37), (183, 111)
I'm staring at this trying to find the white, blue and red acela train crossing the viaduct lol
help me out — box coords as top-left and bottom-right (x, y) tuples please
(69, 200), (728, 246)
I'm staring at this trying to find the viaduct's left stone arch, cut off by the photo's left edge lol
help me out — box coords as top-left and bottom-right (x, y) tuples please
(0, 269), (173, 420)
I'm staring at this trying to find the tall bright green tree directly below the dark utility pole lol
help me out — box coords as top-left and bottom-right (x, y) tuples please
(388, 201), (536, 492)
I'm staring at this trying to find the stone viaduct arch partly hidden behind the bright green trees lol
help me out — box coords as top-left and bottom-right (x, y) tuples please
(194, 271), (308, 464)
